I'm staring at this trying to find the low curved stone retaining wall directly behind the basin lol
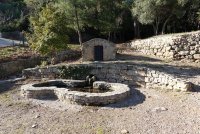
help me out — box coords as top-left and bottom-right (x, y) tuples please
(23, 63), (192, 91)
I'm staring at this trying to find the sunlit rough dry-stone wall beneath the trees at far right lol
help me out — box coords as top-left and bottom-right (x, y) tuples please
(126, 31), (200, 62)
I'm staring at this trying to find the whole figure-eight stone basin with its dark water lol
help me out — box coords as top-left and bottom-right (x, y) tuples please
(21, 79), (130, 105)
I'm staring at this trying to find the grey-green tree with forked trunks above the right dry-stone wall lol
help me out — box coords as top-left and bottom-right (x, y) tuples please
(132, 0), (189, 35)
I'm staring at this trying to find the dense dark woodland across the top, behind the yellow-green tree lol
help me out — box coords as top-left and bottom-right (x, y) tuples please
(0, 0), (200, 44)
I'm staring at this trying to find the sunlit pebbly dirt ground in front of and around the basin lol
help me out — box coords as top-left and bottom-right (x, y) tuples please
(0, 80), (200, 134)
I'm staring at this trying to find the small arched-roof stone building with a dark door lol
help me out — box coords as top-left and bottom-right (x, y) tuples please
(82, 38), (116, 61)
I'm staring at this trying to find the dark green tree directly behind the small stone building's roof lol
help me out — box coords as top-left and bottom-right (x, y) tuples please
(81, 0), (124, 40)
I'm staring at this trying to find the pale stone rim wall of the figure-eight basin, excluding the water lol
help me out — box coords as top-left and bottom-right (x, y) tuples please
(21, 80), (130, 105)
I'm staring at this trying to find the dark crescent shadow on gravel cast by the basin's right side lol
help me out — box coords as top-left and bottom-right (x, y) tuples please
(104, 87), (146, 108)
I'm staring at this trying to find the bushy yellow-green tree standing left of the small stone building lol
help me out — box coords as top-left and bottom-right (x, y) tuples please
(27, 5), (69, 57)
